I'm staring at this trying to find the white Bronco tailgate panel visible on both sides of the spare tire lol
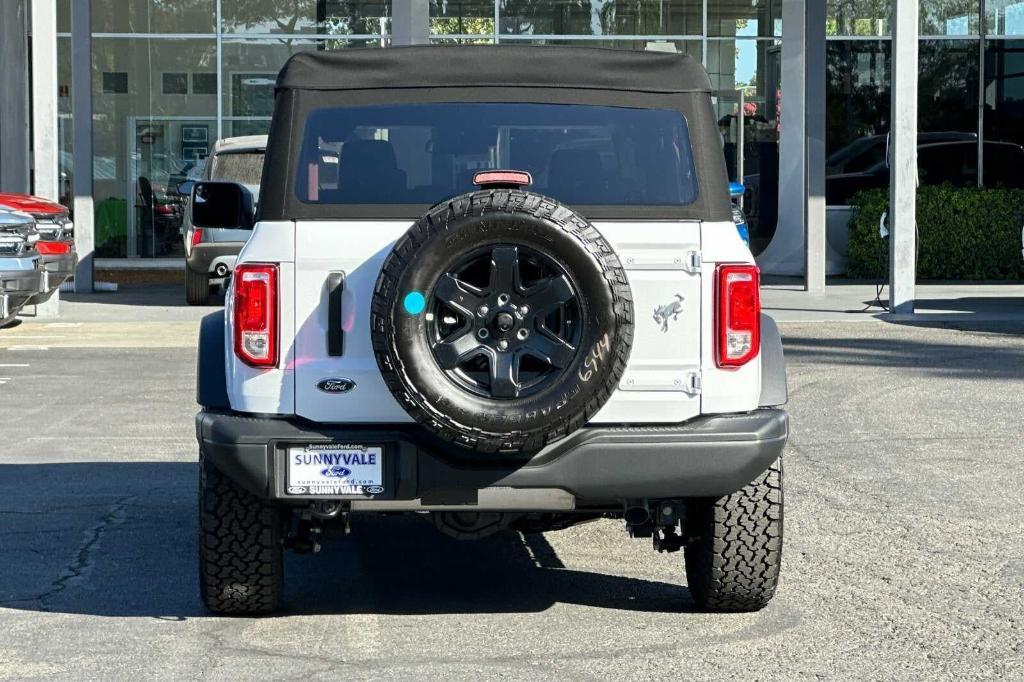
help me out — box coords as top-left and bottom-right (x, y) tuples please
(294, 220), (700, 423)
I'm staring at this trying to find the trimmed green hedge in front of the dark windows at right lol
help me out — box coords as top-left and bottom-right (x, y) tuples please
(846, 185), (1024, 280)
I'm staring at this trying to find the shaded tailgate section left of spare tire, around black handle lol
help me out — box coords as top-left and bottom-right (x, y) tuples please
(295, 220), (413, 424)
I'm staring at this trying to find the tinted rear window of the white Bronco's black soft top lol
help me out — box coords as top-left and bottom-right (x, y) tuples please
(295, 103), (697, 206)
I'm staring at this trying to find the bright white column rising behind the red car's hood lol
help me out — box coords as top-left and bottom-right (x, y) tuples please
(32, 0), (60, 201)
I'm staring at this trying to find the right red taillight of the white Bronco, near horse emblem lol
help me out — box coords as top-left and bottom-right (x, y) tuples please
(715, 265), (761, 367)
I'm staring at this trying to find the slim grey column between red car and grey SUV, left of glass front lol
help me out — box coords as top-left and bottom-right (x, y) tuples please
(71, 0), (96, 293)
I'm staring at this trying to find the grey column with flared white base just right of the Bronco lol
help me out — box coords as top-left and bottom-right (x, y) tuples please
(758, 0), (838, 284)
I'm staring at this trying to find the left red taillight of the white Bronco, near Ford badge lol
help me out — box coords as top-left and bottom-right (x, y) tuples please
(232, 263), (278, 367)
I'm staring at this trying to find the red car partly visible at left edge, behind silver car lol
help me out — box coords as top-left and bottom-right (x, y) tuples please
(0, 193), (78, 305)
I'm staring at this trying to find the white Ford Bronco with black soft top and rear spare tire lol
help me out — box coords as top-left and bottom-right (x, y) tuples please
(190, 46), (788, 613)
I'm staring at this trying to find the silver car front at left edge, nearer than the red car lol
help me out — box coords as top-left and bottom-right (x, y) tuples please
(0, 208), (43, 327)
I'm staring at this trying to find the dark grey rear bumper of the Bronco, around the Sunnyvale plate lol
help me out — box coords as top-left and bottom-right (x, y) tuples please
(196, 409), (788, 511)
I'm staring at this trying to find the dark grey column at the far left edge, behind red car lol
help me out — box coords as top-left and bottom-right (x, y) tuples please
(0, 0), (30, 193)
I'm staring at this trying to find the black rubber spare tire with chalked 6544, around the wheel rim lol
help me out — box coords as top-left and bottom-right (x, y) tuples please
(371, 189), (633, 453)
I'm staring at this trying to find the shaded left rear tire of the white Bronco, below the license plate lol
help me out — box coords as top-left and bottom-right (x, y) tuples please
(199, 448), (285, 615)
